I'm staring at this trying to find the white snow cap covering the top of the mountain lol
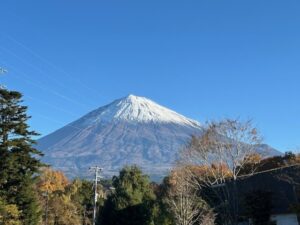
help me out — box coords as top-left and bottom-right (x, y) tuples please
(82, 94), (200, 127)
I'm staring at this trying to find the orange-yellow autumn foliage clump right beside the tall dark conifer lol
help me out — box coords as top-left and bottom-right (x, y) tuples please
(37, 168), (69, 193)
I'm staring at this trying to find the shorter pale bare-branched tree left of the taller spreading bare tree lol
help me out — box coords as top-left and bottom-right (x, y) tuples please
(167, 167), (214, 225)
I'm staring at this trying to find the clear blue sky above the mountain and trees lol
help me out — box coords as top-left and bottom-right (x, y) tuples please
(0, 0), (300, 151)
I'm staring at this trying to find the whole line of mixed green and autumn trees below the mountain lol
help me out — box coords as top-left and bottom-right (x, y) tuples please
(0, 88), (300, 225)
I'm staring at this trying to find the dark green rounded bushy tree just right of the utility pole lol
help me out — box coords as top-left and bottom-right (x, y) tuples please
(99, 166), (155, 225)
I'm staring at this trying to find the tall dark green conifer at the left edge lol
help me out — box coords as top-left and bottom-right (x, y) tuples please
(0, 88), (42, 225)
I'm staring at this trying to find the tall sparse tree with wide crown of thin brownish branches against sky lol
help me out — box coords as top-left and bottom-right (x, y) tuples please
(182, 119), (261, 224)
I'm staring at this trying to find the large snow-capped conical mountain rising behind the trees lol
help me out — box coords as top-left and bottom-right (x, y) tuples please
(38, 95), (202, 177)
